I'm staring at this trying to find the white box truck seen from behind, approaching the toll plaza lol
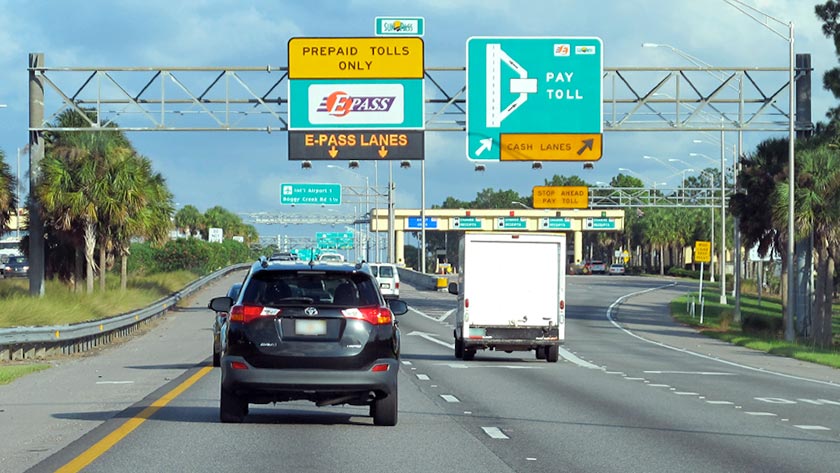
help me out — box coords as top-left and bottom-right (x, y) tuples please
(448, 232), (566, 363)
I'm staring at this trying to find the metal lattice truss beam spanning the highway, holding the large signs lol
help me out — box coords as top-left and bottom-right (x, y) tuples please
(29, 60), (790, 133)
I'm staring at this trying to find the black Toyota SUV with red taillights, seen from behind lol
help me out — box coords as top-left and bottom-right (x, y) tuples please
(209, 258), (408, 425)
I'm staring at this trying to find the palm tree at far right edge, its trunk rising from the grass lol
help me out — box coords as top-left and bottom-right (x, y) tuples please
(773, 145), (840, 348)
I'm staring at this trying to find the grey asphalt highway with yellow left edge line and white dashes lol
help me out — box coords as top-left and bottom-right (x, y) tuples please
(0, 275), (840, 472)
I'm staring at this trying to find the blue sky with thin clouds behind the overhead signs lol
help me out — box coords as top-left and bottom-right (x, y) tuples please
(0, 0), (837, 242)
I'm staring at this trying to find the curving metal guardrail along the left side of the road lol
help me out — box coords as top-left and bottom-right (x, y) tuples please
(0, 263), (250, 362)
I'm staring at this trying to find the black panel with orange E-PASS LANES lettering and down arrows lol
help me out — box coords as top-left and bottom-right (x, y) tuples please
(289, 130), (424, 161)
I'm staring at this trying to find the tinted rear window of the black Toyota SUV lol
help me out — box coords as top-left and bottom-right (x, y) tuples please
(242, 271), (379, 307)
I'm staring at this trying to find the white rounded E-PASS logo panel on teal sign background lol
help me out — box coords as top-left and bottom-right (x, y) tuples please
(307, 83), (405, 125)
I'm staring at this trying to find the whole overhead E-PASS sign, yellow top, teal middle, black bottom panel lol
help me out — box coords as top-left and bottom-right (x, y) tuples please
(288, 37), (425, 160)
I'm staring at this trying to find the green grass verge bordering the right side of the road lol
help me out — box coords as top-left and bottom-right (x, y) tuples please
(671, 284), (840, 368)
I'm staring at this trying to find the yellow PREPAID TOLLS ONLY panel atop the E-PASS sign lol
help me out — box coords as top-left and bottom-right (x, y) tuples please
(288, 37), (424, 79)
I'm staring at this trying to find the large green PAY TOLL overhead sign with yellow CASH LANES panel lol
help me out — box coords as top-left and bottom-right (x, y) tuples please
(466, 37), (604, 161)
